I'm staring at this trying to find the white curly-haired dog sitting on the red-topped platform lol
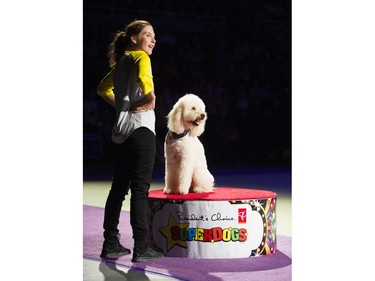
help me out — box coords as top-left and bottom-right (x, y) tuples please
(164, 94), (214, 194)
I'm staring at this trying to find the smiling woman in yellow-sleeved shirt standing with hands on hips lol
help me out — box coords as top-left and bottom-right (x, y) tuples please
(97, 20), (163, 262)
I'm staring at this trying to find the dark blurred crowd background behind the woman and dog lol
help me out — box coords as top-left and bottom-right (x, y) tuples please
(83, 0), (291, 173)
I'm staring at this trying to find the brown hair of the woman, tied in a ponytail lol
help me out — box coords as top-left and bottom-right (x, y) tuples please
(108, 20), (151, 67)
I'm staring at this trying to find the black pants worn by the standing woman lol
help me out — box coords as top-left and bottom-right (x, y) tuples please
(103, 127), (156, 249)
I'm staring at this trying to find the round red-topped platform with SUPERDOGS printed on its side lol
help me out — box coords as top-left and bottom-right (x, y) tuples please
(149, 187), (277, 258)
